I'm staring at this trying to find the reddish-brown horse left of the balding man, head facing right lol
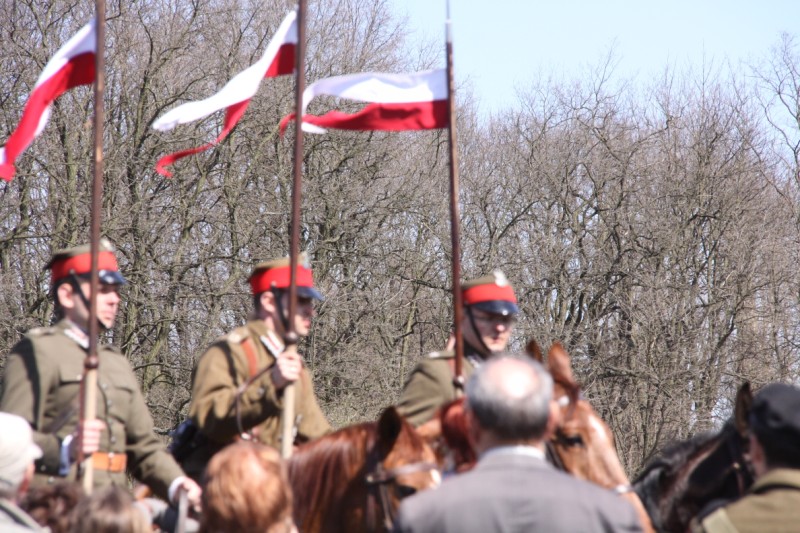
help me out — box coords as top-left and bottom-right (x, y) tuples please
(289, 407), (440, 533)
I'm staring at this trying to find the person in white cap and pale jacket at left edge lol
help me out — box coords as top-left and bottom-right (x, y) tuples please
(0, 413), (49, 533)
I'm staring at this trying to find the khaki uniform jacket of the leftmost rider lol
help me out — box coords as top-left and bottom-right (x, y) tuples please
(0, 320), (183, 498)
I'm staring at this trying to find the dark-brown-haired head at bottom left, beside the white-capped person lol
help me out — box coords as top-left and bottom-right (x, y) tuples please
(20, 481), (86, 533)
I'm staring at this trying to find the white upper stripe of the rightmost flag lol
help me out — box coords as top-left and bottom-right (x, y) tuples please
(303, 69), (447, 112)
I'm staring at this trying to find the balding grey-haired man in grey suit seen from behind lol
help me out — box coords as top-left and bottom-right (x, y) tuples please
(395, 356), (641, 533)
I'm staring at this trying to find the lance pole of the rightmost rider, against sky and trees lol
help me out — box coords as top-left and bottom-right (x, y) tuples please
(445, 1), (464, 396)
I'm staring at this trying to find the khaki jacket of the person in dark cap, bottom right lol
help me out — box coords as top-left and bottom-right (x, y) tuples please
(692, 468), (800, 533)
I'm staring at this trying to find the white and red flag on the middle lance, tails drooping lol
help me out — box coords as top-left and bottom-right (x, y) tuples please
(153, 11), (297, 177)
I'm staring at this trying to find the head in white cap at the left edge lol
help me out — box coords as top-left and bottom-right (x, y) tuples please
(0, 413), (42, 502)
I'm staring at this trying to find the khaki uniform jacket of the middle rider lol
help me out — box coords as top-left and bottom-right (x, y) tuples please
(184, 320), (331, 476)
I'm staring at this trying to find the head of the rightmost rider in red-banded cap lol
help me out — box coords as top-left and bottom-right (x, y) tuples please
(461, 270), (519, 358)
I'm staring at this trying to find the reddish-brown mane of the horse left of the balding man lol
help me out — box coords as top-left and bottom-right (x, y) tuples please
(288, 422), (377, 531)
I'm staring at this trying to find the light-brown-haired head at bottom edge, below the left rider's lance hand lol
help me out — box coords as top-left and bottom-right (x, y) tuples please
(71, 485), (153, 533)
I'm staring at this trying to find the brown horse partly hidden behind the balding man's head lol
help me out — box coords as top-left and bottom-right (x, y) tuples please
(417, 341), (653, 531)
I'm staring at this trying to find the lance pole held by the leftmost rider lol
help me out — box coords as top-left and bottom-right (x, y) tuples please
(78, 0), (106, 494)
